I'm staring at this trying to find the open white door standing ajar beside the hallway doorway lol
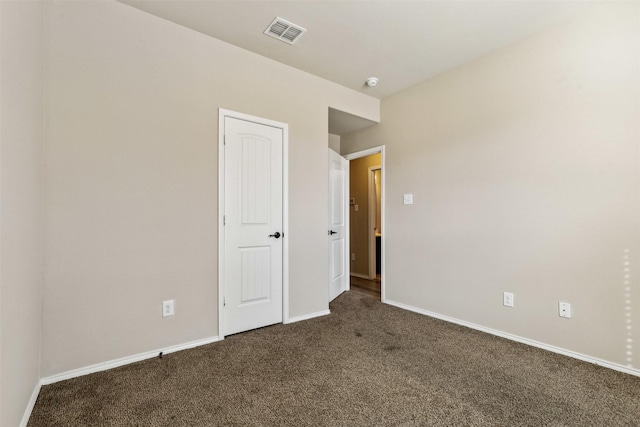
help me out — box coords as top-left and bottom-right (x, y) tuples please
(329, 150), (349, 301)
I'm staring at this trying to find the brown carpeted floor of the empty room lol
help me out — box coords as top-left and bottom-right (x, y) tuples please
(28, 292), (640, 427)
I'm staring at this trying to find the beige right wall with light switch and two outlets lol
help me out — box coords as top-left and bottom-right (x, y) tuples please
(341, 2), (640, 369)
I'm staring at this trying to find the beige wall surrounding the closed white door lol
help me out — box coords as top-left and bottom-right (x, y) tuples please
(42, 1), (379, 376)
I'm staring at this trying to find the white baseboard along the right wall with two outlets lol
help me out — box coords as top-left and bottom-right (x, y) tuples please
(384, 300), (640, 377)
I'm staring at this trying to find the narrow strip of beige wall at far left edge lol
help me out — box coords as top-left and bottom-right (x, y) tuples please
(0, 1), (44, 427)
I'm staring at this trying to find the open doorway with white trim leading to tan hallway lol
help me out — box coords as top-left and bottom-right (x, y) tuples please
(345, 146), (385, 302)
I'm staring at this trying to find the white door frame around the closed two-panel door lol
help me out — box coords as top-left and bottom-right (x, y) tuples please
(218, 108), (289, 340)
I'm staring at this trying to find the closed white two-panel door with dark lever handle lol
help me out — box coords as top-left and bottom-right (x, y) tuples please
(223, 117), (284, 335)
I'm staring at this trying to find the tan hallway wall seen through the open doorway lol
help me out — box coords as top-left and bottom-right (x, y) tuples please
(349, 154), (382, 277)
